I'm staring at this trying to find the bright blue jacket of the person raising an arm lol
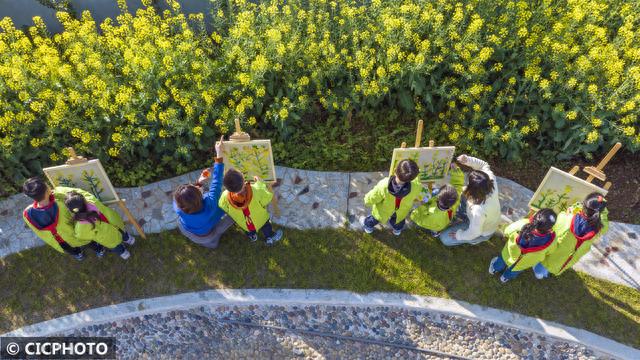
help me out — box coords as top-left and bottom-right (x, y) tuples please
(173, 162), (224, 236)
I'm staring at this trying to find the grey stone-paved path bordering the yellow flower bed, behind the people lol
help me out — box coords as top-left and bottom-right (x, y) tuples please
(0, 166), (640, 289)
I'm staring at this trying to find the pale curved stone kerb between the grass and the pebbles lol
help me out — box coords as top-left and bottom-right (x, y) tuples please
(2, 289), (640, 359)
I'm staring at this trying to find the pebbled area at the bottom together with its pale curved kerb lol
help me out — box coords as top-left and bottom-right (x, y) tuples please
(3, 289), (640, 359)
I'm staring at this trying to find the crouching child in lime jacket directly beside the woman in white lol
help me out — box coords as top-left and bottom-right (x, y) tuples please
(411, 164), (464, 237)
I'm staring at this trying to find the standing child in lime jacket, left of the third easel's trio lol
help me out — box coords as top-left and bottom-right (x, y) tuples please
(362, 160), (422, 236)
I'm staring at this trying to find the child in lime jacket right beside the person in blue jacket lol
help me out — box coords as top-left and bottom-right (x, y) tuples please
(218, 169), (282, 245)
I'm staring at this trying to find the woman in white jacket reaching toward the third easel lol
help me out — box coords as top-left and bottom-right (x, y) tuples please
(440, 155), (500, 246)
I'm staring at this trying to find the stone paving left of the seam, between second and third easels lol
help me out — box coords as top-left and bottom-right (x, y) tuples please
(271, 169), (349, 229)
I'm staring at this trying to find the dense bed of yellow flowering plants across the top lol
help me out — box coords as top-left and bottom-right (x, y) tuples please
(0, 0), (640, 195)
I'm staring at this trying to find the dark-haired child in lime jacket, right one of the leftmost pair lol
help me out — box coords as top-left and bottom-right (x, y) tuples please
(64, 190), (135, 260)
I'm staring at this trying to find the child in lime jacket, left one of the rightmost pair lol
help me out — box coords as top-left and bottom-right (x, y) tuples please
(489, 209), (557, 283)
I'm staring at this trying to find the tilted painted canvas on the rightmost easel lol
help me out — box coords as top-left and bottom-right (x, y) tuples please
(529, 167), (607, 213)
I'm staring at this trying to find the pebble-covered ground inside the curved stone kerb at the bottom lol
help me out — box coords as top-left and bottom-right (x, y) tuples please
(60, 305), (607, 359)
